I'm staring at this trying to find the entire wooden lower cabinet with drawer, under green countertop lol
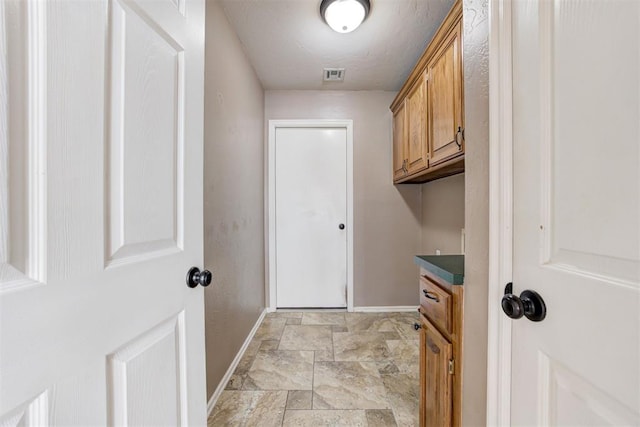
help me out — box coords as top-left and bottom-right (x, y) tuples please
(419, 269), (463, 427)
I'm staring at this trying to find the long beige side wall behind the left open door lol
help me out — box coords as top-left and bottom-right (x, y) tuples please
(204, 0), (264, 398)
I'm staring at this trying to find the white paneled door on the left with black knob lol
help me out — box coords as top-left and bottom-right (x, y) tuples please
(0, 0), (206, 426)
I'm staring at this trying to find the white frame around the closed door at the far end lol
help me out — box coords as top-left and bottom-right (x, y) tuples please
(265, 120), (353, 312)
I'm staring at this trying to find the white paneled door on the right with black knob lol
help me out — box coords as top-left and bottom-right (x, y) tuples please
(511, 0), (640, 426)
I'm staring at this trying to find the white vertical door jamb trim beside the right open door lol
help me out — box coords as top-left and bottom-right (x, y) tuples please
(487, 0), (513, 426)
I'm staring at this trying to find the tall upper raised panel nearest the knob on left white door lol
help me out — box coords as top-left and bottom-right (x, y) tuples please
(107, 2), (185, 263)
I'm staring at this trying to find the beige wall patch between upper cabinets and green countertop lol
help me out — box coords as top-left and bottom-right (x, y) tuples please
(421, 174), (464, 255)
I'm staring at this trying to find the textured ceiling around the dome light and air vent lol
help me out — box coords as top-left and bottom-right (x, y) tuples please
(220, 0), (453, 91)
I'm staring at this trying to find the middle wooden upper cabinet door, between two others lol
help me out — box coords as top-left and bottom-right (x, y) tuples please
(406, 74), (429, 175)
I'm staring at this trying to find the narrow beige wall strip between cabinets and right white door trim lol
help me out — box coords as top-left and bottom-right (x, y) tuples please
(462, 0), (489, 426)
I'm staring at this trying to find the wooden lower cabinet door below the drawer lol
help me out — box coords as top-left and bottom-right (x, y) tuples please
(420, 318), (453, 427)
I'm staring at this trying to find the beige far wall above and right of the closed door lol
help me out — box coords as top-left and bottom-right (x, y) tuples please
(265, 91), (421, 307)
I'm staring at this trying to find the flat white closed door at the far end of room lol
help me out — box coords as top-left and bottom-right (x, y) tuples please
(274, 127), (351, 308)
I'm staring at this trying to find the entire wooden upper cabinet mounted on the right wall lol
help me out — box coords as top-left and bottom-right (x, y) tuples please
(391, 0), (464, 184)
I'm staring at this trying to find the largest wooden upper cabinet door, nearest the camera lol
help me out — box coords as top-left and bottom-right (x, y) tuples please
(427, 24), (464, 165)
